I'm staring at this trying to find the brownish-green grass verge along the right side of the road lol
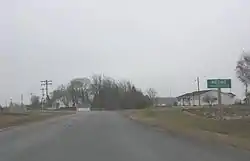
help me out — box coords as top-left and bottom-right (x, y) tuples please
(130, 108), (250, 150)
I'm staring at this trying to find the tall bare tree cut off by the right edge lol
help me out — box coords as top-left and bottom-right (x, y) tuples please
(236, 52), (250, 103)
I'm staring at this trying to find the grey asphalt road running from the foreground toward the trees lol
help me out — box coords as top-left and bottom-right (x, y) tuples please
(0, 111), (250, 161)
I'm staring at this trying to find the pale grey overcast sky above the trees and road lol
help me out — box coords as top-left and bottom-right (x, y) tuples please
(0, 0), (250, 103)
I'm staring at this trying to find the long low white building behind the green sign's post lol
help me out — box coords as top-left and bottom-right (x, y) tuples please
(177, 90), (236, 106)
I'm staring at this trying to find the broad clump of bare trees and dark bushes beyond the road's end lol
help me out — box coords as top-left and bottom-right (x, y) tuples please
(31, 74), (156, 110)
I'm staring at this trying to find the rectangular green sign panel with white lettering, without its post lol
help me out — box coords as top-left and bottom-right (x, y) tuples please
(207, 79), (231, 88)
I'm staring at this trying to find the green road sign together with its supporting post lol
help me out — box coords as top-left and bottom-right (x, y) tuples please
(207, 79), (232, 119)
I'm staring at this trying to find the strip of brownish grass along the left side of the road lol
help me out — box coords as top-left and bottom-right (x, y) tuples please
(0, 111), (74, 129)
